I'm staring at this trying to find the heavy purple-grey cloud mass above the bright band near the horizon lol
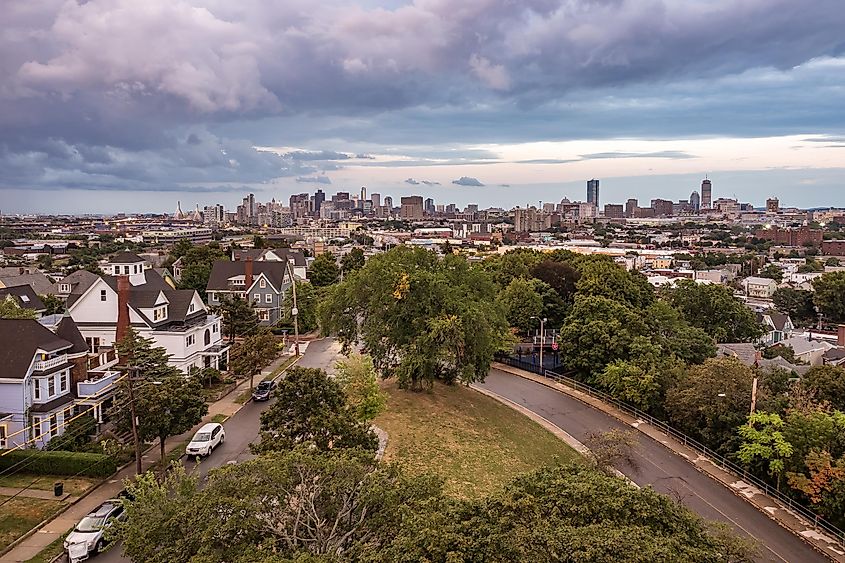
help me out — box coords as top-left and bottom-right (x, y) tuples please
(0, 0), (845, 197)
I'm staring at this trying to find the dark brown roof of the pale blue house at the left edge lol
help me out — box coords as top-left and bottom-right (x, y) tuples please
(0, 319), (72, 379)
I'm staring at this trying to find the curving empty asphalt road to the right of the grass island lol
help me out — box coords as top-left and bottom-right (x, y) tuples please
(480, 369), (828, 563)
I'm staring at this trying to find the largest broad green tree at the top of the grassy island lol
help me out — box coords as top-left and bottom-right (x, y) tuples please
(319, 246), (509, 389)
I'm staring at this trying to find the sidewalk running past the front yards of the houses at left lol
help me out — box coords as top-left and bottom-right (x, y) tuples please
(0, 354), (290, 563)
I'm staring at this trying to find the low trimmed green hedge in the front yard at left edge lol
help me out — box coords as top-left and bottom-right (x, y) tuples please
(0, 449), (117, 477)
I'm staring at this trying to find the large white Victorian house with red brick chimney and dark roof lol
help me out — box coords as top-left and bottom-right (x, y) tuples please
(58, 252), (229, 373)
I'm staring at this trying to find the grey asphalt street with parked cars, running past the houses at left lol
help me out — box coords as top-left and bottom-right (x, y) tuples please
(95, 339), (339, 563)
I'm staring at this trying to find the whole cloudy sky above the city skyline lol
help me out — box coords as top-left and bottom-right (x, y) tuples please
(0, 0), (845, 213)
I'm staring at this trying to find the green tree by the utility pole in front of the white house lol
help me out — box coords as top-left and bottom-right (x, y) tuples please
(111, 330), (208, 470)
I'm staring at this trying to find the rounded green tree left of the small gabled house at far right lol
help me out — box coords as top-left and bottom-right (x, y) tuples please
(663, 280), (763, 342)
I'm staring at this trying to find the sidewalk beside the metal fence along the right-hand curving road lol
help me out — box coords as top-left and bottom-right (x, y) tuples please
(493, 363), (845, 561)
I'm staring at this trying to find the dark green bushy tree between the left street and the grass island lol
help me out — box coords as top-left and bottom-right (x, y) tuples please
(252, 367), (378, 453)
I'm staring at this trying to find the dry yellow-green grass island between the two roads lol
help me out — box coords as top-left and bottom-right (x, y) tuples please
(375, 382), (580, 498)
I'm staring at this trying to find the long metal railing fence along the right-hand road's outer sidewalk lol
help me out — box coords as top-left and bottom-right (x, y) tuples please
(497, 357), (845, 543)
